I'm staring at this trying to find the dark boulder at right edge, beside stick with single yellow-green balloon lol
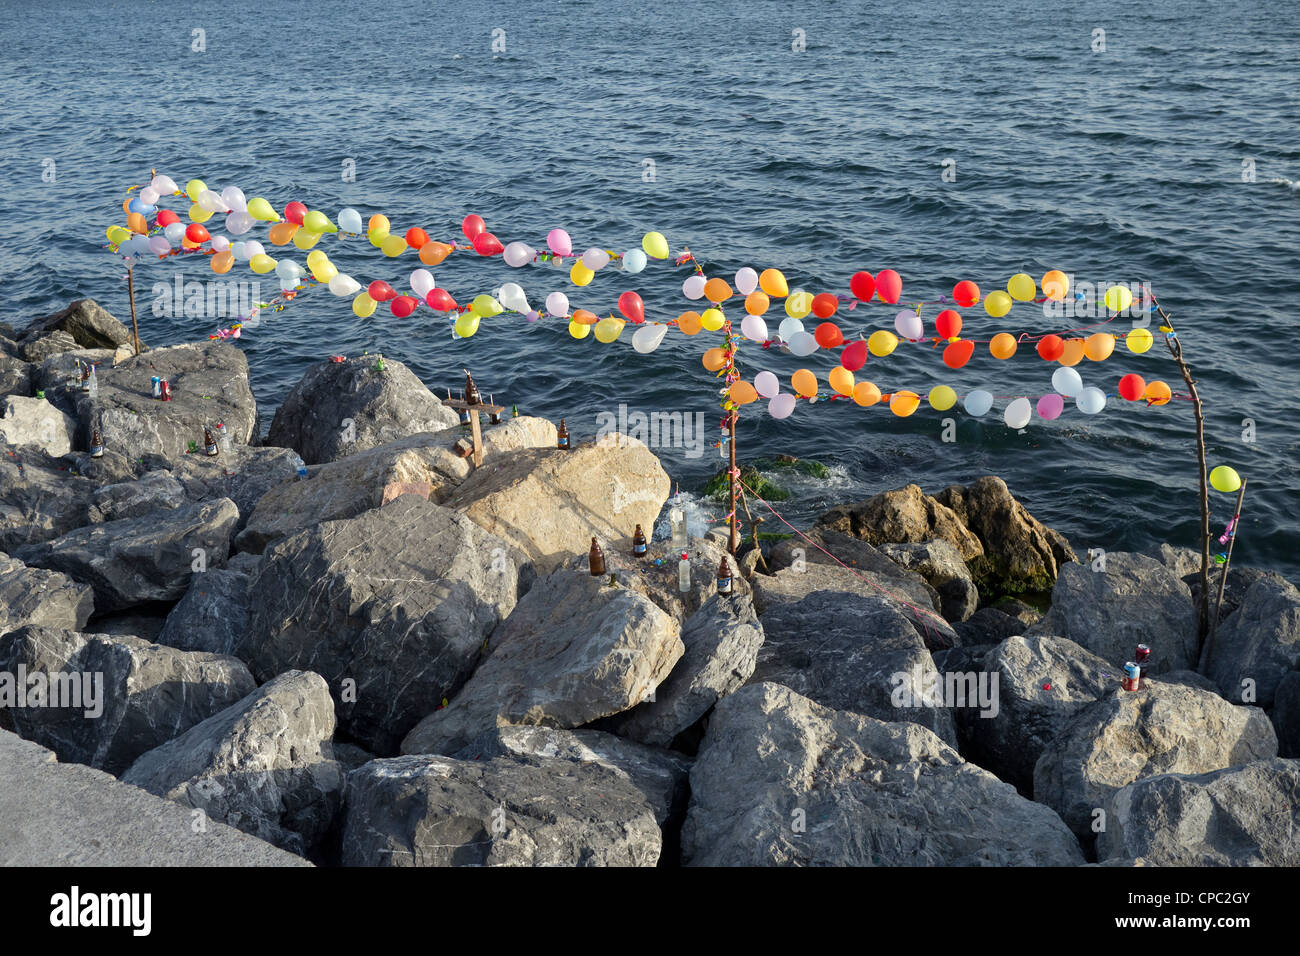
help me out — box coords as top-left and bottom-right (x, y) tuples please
(1205, 575), (1300, 708)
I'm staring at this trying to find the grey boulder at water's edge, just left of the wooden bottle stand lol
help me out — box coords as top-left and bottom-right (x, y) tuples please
(267, 355), (460, 464)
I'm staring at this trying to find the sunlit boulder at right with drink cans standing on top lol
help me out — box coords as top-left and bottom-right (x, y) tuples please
(1034, 679), (1278, 840)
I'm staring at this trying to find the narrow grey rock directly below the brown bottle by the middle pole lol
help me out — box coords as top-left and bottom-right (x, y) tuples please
(610, 594), (763, 747)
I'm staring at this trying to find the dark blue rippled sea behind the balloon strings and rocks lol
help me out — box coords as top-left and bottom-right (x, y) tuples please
(0, 0), (1300, 579)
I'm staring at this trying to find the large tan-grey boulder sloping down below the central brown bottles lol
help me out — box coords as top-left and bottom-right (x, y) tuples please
(402, 568), (685, 753)
